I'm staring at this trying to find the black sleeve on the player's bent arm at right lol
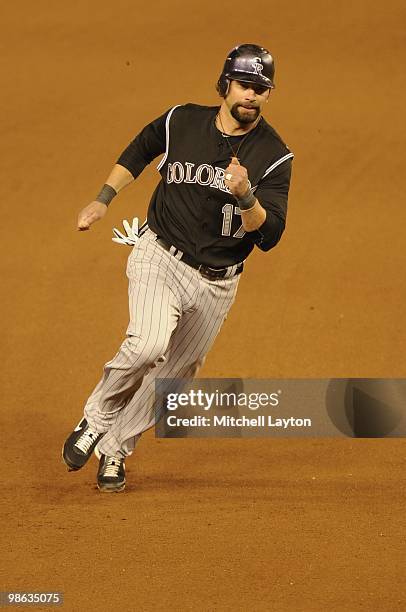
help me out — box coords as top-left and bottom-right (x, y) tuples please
(252, 158), (292, 251)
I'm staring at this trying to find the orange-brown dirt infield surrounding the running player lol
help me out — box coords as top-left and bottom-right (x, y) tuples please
(0, 0), (406, 612)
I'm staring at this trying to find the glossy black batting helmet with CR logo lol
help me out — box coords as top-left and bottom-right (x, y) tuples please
(217, 44), (275, 98)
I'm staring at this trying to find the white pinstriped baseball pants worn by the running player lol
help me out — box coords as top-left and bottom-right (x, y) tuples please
(84, 228), (240, 456)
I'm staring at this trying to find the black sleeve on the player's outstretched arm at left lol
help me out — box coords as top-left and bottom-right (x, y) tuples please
(116, 110), (170, 178)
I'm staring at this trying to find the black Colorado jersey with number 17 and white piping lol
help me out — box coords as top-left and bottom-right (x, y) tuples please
(117, 104), (293, 267)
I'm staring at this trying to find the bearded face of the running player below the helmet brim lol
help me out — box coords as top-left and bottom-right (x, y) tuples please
(225, 81), (270, 124)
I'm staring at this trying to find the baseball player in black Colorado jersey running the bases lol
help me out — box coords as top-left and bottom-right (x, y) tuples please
(62, 44), (293, 491)
